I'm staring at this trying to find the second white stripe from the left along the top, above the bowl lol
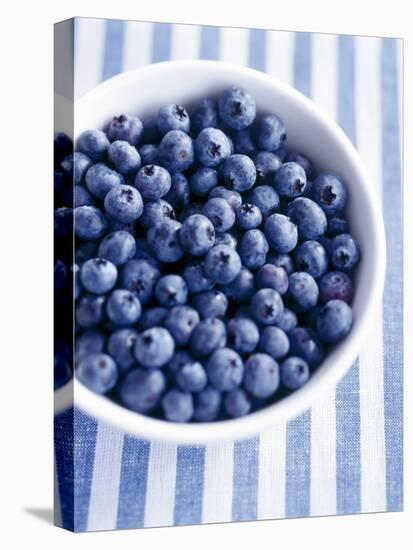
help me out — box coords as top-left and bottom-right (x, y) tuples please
(122, 21), (153, 71)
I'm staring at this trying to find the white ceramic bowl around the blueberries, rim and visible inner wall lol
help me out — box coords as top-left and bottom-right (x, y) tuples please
(65, 61), (385, 444)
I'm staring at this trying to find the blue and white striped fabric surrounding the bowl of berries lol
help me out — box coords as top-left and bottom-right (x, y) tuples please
(55, 19), (403, 531)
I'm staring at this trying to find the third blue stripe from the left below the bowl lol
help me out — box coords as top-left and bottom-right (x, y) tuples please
(174, 447), (205, 525)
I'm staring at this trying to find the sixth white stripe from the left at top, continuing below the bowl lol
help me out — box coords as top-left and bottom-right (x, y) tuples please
(310, 34), (337, 516)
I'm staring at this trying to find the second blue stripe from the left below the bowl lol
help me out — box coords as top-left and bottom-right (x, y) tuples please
(116, 435), (150, 529)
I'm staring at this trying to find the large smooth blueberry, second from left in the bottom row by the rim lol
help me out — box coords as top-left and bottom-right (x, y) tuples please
(119, 368), (166, 414)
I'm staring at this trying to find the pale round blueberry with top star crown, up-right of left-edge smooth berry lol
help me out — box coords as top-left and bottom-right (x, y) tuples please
(104, 185), (143, 223)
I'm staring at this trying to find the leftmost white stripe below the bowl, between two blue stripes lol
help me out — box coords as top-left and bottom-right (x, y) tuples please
(87, 423), (123, 531)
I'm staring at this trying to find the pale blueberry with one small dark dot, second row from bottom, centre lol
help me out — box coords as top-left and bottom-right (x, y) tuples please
(206, 348), (244, 391)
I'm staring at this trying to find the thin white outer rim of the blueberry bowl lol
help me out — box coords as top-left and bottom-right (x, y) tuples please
(62, 60), (386, 445)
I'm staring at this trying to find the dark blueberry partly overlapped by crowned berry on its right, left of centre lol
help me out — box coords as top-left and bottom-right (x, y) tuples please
(147, 220), (184, 263)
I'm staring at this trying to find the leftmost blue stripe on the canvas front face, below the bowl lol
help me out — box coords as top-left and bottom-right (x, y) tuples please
(73, 409), (98, 531)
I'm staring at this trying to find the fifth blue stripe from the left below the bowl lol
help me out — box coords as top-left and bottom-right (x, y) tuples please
(285, 411), (311, 517)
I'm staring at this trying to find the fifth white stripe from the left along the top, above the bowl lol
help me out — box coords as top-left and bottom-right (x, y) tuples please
(267, 31), (294, 84)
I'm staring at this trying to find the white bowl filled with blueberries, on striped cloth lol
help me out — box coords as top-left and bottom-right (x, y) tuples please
(61, 61), (385, 444)
